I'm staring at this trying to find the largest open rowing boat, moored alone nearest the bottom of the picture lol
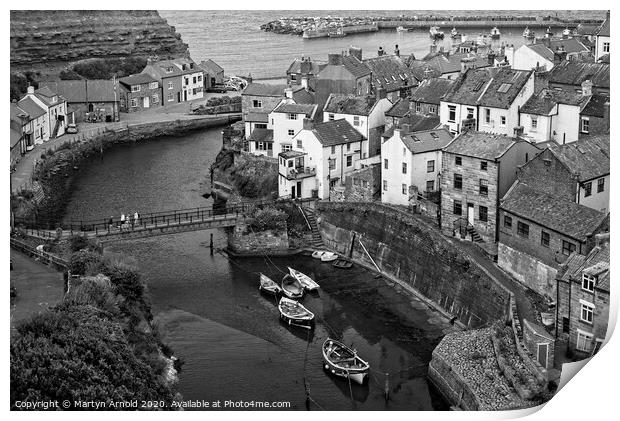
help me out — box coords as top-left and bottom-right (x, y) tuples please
(323, 338), (370, 384)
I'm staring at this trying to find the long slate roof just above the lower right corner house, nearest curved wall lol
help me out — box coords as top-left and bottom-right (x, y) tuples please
(500, 181), (606, 241)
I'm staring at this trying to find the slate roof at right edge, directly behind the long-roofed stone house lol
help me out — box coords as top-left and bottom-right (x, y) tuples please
(549, 134), (610, 182)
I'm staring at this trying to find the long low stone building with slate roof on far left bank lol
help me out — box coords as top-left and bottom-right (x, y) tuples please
(40, 79), (120, 123)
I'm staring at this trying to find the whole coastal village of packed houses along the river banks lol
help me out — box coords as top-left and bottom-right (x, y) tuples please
(10, 12), (610, 410)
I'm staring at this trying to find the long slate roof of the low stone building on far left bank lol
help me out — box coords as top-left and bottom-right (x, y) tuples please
(40, 79), (120, 103)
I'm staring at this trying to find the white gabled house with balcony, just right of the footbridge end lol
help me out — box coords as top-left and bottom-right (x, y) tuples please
(278, 119), (366, 199)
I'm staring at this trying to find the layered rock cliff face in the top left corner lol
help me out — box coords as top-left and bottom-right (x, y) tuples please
(11, 10), (189, 68)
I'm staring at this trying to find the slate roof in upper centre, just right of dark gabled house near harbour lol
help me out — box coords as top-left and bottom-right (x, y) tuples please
(364, 55), (418, 92)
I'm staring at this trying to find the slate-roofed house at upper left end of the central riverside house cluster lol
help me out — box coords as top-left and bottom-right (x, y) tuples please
(241, 83), (286, 139)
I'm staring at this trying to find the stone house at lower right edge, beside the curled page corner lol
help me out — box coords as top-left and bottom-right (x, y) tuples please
(556, 234), (611, 359)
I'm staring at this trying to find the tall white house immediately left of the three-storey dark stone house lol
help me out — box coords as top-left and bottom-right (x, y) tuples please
(381, 125), (452, 206)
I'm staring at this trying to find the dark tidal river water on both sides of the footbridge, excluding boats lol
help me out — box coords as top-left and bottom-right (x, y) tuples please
(66, 128), (452, 410)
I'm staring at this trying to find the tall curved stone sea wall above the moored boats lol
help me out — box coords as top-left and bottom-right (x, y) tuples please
(316, 202), (509, 328)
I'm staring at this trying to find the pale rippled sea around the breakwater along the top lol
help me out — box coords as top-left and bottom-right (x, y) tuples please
(159, 10), (605, 79)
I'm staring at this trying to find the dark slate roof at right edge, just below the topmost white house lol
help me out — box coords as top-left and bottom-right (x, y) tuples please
(547, 60), (610, 97)
